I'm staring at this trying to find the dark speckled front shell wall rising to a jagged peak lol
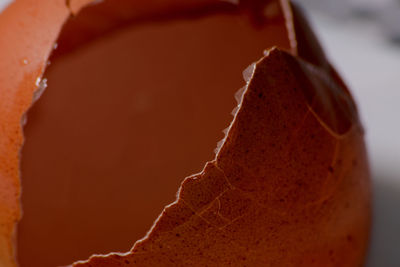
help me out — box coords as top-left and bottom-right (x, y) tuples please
(73, 49), (370, 267)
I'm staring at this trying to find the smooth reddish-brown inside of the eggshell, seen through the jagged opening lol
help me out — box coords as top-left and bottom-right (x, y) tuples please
(18, 2), (288, 267)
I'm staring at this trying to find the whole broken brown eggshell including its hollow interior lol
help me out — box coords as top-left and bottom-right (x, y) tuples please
(0, 0), (371, 267)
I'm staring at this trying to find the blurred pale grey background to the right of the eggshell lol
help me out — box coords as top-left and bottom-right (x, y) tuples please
(297, 0), (400, 267)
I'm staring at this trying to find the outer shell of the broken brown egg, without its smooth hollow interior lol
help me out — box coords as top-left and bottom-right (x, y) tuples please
(0, 0), (370, 267)
